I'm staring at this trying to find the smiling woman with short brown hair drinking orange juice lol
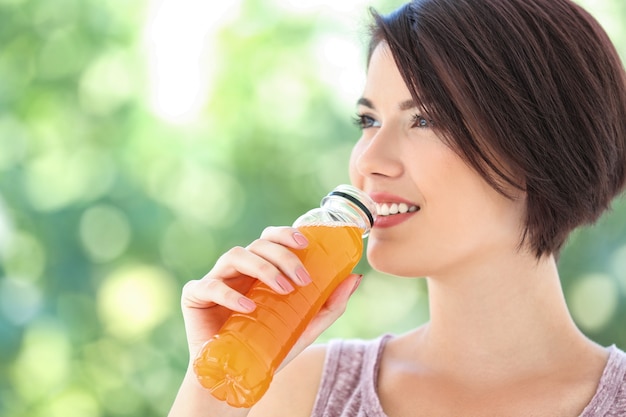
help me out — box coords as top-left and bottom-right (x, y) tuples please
(170, 0), (626, 417)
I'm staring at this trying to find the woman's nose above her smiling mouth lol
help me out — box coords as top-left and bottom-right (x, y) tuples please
(351, 126), (403, 177)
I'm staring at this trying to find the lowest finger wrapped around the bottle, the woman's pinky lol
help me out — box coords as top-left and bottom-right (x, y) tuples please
(181, 279), (256, 313)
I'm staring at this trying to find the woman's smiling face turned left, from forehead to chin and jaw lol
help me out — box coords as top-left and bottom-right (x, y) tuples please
(350, 43), (525, 277)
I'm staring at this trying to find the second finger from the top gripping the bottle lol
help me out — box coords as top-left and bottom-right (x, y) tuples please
(246, 239), (311, 289)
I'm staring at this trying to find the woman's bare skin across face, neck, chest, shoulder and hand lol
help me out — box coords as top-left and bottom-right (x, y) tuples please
(170, 43), (607, 417)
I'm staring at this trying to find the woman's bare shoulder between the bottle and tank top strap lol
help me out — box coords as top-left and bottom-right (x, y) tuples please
(249, 345), (327, 417)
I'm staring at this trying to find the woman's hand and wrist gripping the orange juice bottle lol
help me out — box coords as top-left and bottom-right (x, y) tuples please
(170, 227), (361, 417)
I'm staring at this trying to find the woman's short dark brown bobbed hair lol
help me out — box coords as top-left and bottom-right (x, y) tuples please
(370, 0), (626, 258)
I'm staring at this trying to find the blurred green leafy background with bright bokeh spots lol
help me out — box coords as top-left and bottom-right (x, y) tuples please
(0, 0), (626, 417)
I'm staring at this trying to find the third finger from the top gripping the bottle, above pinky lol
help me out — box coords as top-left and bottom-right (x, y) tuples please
(210, 245), (299, 294)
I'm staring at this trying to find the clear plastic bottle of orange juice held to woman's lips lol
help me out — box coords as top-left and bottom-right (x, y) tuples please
(193, 185), (376, 407)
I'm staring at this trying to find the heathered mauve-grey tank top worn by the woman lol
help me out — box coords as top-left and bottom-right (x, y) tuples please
(311, 335), (626, 417)
